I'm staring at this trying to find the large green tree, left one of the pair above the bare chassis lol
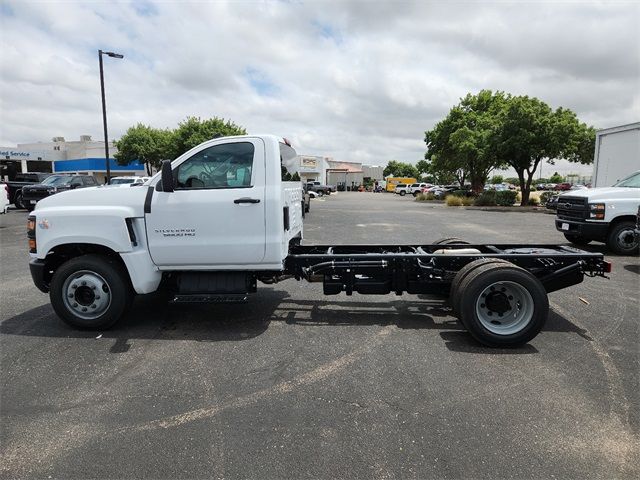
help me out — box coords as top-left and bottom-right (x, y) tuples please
(425, 90), (505, 191)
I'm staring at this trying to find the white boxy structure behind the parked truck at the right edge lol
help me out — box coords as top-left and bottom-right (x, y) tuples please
(592, 122), (640, 187)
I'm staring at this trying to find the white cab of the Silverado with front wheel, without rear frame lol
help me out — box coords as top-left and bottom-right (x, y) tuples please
(28, 135), (302, 327)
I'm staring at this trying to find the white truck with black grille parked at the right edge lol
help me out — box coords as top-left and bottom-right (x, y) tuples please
(556, 170), (640, 255)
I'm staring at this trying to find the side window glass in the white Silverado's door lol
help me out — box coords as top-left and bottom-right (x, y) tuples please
(176, 142), (254, 190)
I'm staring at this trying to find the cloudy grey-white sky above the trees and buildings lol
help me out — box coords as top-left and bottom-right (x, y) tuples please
(0, 0), (640, 176)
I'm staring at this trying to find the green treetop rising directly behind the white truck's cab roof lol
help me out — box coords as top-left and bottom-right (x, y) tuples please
(170, 117), (247, 158)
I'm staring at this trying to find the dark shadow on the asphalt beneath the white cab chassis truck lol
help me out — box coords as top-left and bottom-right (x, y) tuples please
(0, 289), (592, 355)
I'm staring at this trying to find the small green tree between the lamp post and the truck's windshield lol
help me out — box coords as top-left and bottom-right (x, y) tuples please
(114, 123), (171, 175)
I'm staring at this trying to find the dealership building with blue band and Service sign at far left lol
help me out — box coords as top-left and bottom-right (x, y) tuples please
(0, 135), (145, 187)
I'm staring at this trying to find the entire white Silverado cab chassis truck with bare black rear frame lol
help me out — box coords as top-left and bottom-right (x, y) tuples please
(27, 135), (611, 347)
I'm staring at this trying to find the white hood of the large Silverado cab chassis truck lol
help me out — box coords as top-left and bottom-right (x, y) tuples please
(36, 183), (147, 217)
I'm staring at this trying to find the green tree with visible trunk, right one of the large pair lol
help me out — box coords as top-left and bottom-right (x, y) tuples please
(498, 96), (595, 205)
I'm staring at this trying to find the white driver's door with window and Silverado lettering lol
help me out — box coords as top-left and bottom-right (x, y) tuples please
(146, 138), (266, 268)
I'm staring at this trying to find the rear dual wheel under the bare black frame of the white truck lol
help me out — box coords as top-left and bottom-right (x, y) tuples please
(458, 264), (549, 347)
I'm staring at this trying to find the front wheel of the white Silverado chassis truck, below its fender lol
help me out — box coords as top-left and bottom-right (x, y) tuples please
(49, 254), (133, 330)
